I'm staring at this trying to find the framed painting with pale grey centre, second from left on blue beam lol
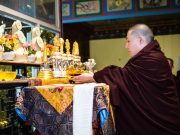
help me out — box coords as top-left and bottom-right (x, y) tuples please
(74, 0), (102, 17)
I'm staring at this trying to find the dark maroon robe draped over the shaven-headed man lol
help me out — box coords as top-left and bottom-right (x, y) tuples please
(94, 40), (180, 135)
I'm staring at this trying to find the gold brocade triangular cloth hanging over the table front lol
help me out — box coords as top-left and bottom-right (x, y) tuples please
(36, 85), (73, 113)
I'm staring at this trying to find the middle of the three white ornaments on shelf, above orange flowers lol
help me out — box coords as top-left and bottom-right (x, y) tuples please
(12, 20), (26, 50)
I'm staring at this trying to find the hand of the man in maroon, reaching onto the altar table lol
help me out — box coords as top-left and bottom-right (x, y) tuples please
(71, 73), (95, 84)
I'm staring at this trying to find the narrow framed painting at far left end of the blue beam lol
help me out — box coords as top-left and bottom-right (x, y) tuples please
(61, 1), (72, 18)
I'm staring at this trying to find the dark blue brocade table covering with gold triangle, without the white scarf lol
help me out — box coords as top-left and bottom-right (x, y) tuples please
(16, 84), (114, 135)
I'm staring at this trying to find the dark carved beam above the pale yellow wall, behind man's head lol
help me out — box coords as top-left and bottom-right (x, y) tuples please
(85, 14), (180, 39)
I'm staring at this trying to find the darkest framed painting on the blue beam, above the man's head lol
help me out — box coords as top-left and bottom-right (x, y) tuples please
(138, 0), (170, 9)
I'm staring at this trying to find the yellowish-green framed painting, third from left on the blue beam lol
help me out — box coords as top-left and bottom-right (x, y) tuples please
(104, 0), (135, 13)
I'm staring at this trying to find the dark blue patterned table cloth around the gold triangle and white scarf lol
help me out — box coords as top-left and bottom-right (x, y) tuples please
(16, 86), (113, 135)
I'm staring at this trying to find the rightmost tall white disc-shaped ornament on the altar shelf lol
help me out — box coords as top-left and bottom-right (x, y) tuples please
(31, 26), (44, 51)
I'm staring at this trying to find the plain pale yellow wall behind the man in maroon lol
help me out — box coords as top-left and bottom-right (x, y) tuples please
(90, 34), (180, 74)
